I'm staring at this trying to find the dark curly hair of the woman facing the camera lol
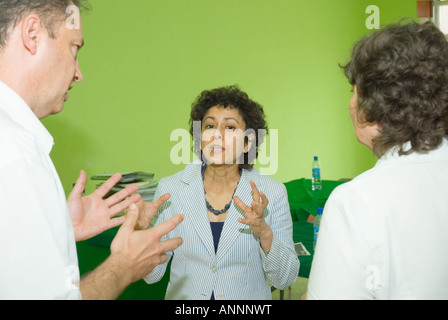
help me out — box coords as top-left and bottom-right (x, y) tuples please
(189, 85), (269, 170)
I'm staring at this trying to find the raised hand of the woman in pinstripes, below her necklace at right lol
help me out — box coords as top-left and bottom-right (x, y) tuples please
(233, 180), (273, 252)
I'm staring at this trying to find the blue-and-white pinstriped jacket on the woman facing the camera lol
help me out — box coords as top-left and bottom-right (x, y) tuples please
(144, 161), (299, 300)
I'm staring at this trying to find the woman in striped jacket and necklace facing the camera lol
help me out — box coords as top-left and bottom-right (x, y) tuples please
(145, 86), (299, 299)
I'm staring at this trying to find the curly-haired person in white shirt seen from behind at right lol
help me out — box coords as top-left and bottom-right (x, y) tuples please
(307, 22), (448, 299)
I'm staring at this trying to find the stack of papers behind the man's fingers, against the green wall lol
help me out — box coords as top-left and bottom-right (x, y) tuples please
(91, 171), (159, 202)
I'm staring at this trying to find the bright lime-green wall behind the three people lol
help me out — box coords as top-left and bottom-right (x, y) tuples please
(43, 0), (416, 297)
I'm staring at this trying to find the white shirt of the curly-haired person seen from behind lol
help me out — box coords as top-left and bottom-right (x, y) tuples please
(308, 140), (448, 299)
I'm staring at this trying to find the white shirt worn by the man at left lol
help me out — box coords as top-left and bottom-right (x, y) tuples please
(0, 81), (81, 299)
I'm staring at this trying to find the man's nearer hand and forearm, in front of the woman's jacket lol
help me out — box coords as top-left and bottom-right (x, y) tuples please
(80, 204), (183, 300)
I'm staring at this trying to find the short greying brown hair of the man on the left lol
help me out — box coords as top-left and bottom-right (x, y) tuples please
(0, 0), (90, 49)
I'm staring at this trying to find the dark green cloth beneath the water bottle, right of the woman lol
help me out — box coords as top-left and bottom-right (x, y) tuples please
(285, 179), (346, 221)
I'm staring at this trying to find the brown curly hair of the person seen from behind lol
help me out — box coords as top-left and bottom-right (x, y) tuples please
(343, 21), (448, 157)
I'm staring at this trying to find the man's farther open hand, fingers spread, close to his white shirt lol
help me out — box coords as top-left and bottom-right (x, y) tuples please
(67, 171), (141, 241)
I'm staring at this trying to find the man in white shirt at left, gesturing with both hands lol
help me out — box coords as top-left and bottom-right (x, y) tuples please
(0, 0), (183, 299)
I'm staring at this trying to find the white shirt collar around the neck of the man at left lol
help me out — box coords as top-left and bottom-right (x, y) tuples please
(0, 81), (54, 154)
